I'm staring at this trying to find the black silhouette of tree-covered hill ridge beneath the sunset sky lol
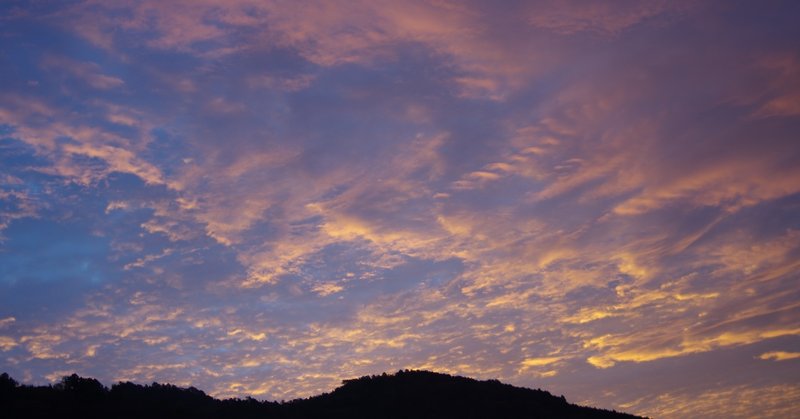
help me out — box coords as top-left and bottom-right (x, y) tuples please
(0, 370), (637, 419)
